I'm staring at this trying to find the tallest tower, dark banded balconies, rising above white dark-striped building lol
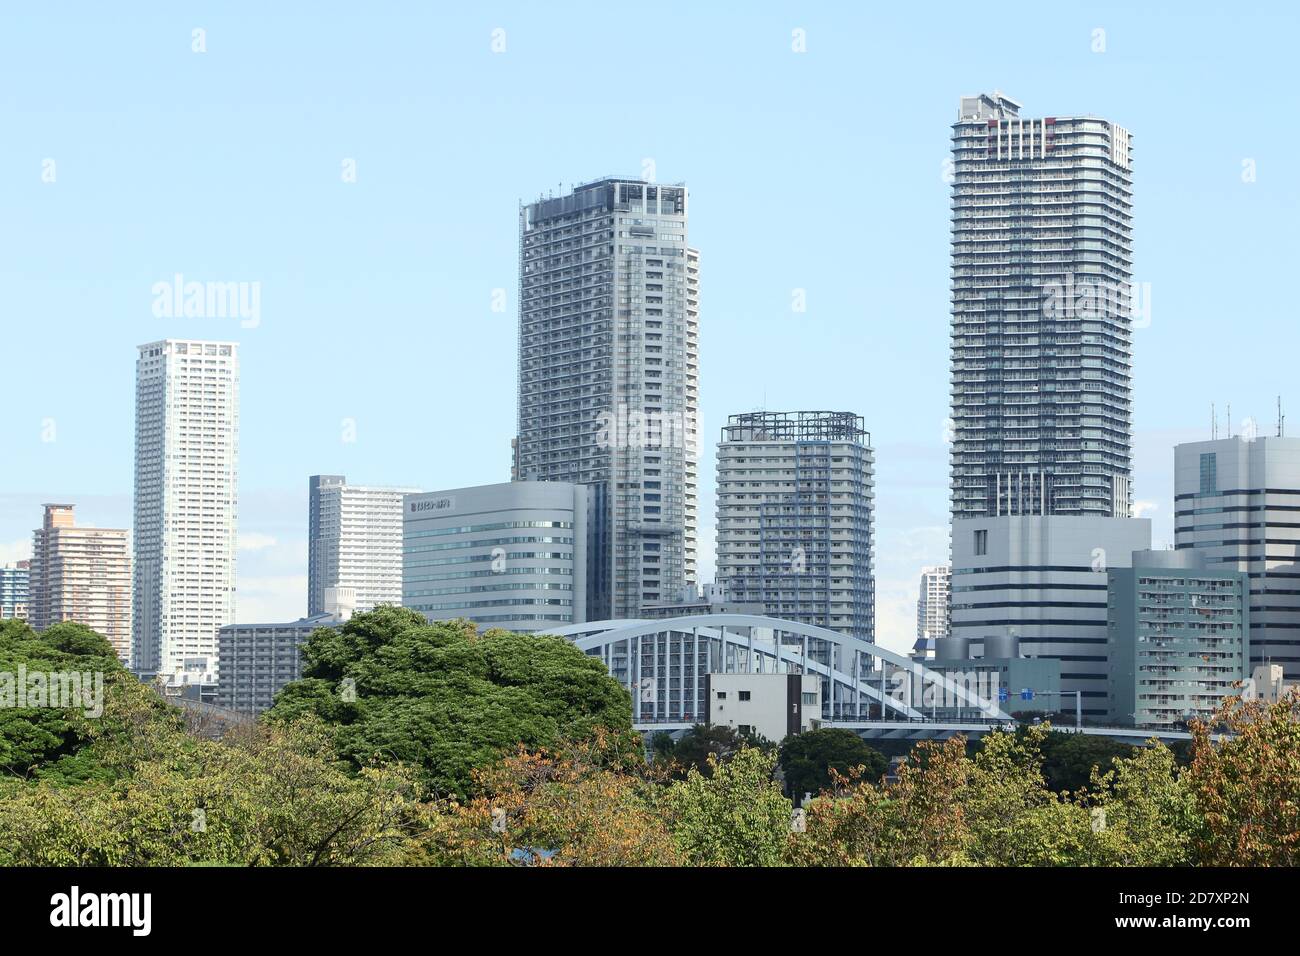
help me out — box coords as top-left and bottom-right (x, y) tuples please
(952, 92), (1132, 520)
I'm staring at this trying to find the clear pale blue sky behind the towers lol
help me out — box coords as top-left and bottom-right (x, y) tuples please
(0, 3), (1300, 648)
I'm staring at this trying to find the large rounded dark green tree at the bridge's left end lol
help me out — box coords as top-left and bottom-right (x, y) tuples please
(268, 606), (632, 796)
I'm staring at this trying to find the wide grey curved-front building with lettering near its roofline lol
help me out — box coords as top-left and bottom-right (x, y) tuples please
(402, 481), (588, 632)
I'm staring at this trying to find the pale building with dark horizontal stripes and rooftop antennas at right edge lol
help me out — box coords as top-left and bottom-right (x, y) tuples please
(1174, 434), (1300, 679)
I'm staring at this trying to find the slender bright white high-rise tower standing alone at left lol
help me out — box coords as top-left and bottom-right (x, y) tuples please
(131, 339), (239, 684)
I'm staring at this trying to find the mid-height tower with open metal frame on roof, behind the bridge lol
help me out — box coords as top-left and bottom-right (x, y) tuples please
(718, 411), (875, 640)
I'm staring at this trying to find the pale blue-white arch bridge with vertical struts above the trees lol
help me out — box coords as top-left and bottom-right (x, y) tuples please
(545, 614), (1011, 731)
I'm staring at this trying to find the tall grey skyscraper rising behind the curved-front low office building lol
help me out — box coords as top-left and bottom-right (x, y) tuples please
(512, 179), (699, 620)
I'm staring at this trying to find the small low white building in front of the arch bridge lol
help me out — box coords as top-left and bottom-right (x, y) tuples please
(705, 674), (822, 743)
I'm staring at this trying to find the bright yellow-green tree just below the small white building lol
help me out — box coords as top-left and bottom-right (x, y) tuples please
(663, 747), (792, 866)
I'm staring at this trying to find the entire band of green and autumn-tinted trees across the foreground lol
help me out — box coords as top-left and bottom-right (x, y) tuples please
(0, 607), (1300, 866)
